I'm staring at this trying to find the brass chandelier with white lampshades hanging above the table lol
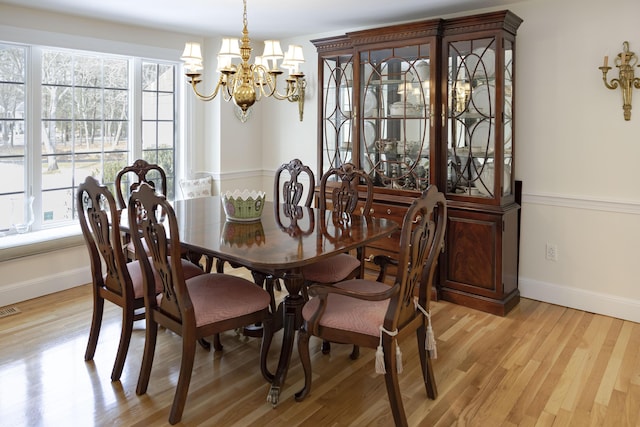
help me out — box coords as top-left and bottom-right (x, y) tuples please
(181, 0), (306, 121)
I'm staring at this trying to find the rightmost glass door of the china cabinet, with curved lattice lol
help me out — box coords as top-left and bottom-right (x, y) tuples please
(447, 37), (513, 198)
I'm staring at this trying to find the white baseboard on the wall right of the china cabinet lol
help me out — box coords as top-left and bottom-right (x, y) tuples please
(518, 277), (640, 323)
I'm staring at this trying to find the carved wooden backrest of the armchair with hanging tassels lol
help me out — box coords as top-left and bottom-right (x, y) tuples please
(384, 185), (447, 330)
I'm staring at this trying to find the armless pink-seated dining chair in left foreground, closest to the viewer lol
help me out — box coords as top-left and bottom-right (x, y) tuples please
(128, 183), (273, 424)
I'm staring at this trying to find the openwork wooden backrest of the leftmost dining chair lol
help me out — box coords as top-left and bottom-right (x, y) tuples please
(76, 176), (134, 302)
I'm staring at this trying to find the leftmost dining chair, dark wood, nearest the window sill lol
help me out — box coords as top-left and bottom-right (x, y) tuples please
(76, 176), (203, 381)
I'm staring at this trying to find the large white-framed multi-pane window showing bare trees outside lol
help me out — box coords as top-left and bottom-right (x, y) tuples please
(0, 44), (178, 235)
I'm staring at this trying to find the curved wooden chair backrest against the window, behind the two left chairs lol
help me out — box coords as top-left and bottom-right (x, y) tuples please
(115, 159), (167, 209)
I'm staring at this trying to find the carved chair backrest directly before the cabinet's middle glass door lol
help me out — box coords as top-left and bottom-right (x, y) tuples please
(318, 163), (373, 215)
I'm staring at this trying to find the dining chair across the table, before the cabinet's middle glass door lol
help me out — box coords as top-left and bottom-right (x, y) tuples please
(302, 163), (373, 359)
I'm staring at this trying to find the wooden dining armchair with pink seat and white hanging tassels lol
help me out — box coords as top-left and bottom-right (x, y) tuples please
(295, 185), (447, 426)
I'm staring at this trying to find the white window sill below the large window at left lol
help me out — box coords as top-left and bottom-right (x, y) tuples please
(0, 224), (84, 262)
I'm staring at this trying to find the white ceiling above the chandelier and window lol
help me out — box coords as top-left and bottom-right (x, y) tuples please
(0, 0), (517, 39)
